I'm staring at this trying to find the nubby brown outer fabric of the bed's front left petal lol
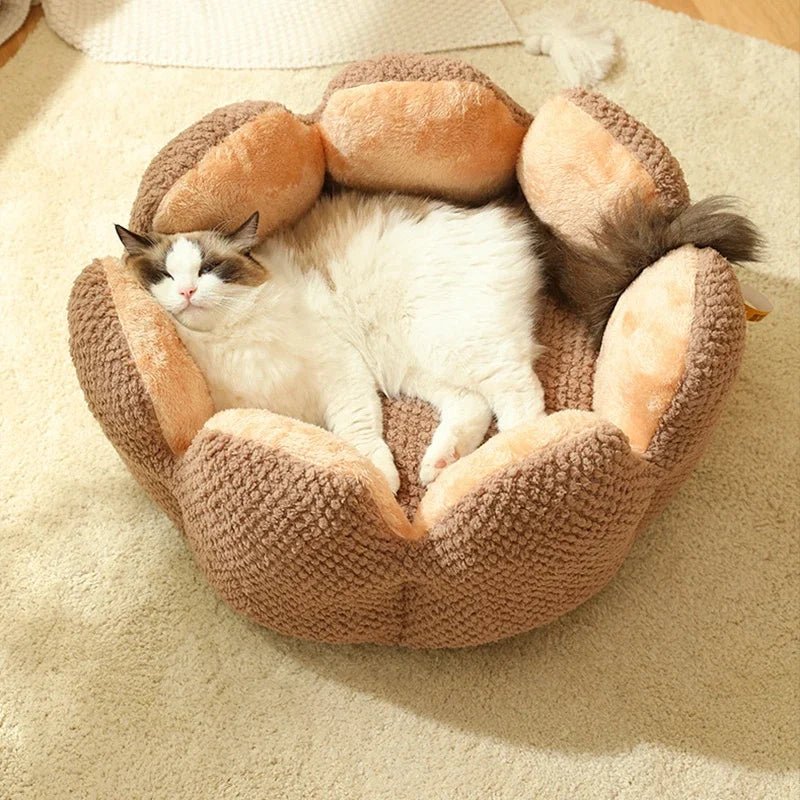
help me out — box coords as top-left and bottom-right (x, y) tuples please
(179, 431), (408, 643)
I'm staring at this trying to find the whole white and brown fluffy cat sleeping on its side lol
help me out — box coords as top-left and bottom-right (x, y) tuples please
(117, 192), (757, 492)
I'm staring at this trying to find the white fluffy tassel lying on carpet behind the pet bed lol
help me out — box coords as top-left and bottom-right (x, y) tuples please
(520, 11), (617, 86)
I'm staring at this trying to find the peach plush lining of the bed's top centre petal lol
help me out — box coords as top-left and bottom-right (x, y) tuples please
(319, 80), (526, 202)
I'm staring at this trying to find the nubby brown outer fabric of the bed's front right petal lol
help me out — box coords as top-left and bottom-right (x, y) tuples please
(403, 423), (653, 647)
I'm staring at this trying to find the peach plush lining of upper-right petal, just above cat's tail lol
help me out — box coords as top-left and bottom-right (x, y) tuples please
(517, 96), (656, 243)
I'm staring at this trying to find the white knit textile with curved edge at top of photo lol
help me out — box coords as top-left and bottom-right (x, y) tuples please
(43, 0), (519, 68)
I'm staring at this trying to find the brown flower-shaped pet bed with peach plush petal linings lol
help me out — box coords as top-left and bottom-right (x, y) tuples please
(69, 56), (744, 647)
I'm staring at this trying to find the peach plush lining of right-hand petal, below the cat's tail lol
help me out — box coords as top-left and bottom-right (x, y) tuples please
(594, 245), (698, 452)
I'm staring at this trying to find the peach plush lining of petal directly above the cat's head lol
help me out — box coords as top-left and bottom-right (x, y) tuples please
(153, 106), (325, 236)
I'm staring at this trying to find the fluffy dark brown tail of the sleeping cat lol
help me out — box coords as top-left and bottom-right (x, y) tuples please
(539, 196), (764, 343)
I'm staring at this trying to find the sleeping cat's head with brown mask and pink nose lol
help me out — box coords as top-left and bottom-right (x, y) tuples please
(115, 211), (268, 331)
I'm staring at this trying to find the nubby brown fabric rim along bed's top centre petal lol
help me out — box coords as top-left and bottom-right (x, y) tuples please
(310, 53), (533, 128)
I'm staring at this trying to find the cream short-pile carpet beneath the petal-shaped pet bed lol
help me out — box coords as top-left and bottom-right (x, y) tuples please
(0, 0), (800, 800)
